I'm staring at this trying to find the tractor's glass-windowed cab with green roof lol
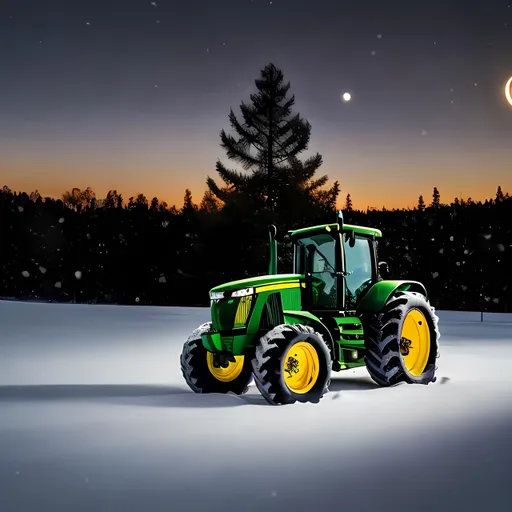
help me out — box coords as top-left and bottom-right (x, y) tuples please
(290, 215), (381, 314)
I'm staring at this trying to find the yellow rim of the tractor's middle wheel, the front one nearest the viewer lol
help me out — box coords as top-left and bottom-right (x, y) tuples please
(283, 341), (320, 395)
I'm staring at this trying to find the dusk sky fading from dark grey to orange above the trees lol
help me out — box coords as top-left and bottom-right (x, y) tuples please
(0, 0), (512, 208)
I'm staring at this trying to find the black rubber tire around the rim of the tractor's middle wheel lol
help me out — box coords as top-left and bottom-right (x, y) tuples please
(252, 324), (332, 405)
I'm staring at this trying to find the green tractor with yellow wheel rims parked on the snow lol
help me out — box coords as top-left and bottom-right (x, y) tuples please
(181, 212), (440, 405)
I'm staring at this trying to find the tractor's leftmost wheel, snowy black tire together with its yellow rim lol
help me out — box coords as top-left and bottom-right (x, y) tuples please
(180, 322), (252, 395)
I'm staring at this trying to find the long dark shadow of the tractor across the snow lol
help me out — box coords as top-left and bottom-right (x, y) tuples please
(0, 377), (378, 408)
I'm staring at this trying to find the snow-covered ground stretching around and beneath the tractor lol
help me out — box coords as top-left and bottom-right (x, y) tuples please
(0, 302), (512, 512)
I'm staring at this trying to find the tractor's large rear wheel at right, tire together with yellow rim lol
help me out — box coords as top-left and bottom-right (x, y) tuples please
(363, 292), (440, 386)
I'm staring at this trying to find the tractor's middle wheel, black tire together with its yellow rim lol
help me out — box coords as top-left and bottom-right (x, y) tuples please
(252, 324), (331, 405)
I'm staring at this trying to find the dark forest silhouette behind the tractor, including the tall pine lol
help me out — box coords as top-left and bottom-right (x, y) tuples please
(0, 64), (512, 312)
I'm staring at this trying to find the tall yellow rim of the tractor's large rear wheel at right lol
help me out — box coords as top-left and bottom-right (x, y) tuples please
(400, 309), (430, 377)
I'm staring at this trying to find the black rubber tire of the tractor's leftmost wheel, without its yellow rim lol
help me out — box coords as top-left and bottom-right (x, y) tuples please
(180, 322), (252, 395)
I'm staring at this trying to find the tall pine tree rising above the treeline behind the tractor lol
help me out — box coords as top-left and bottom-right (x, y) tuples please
(207, 64), (339, 211)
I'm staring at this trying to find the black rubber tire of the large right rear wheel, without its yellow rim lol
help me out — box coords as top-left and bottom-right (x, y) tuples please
(362, 292), (440, 386)
